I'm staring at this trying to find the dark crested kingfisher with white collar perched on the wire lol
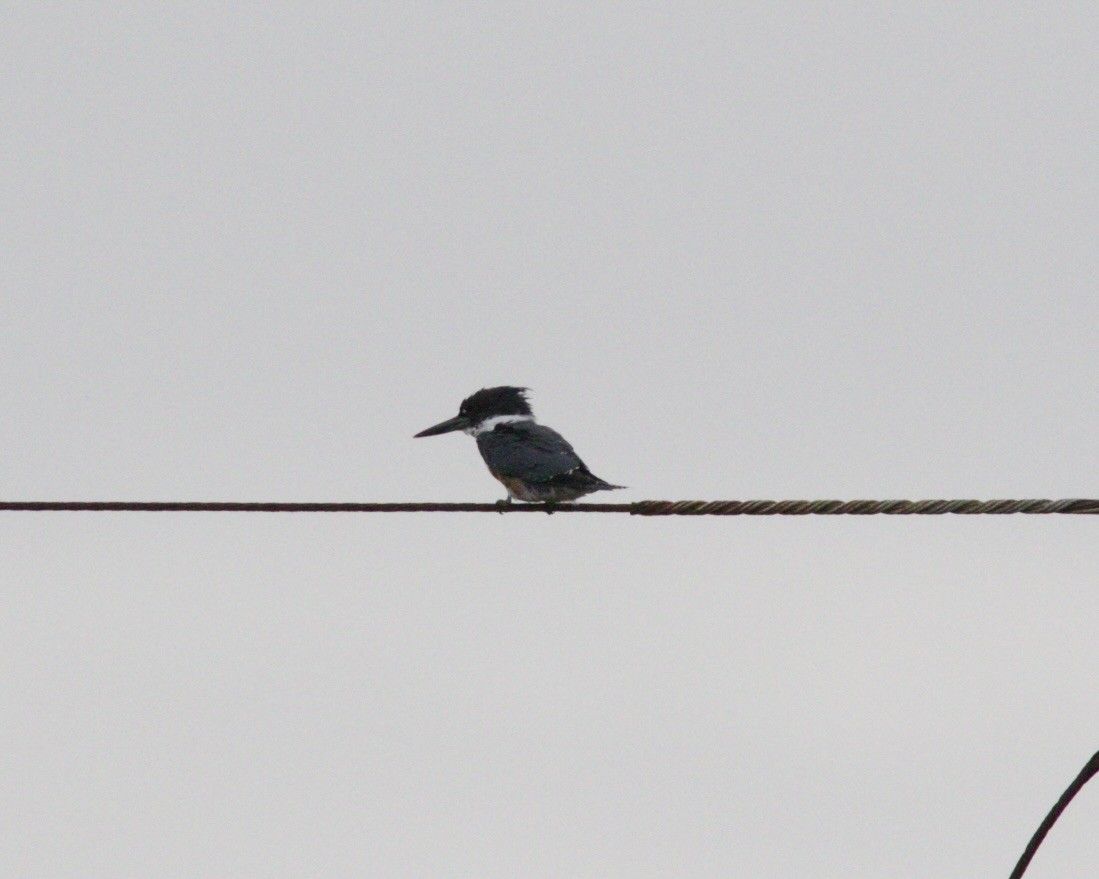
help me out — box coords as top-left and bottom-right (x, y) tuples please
(417, 387), (625, 503)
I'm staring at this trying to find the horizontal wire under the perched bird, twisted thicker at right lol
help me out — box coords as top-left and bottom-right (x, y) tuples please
(0, 498), (1099, 516)
